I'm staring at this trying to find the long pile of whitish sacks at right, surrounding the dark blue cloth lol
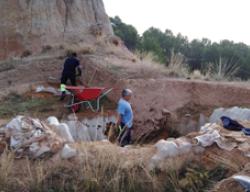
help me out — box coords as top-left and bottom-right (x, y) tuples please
(151, 107), (250, 170)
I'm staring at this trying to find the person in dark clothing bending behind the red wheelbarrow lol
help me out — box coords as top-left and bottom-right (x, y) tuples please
(60, 53), (82, 100)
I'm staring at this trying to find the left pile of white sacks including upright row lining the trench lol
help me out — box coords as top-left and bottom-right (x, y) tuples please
(0, 115), (115, 159)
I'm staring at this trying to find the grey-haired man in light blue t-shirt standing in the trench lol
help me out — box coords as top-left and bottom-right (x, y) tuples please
(117, 89), (133, 146)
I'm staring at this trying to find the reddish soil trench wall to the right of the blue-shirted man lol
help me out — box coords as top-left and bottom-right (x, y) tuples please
(124, 79), (250, 142)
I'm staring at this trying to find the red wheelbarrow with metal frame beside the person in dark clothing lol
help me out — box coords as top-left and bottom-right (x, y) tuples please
(65, 86), (113, 113)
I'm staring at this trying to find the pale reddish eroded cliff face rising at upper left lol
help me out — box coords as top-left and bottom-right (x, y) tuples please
(0, 0), (113, 60)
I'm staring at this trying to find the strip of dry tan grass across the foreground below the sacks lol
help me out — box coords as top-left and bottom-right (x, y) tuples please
(0, 142), (229, 192)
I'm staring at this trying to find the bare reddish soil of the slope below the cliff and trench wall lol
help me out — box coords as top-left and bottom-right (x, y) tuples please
(0, 47), (250, 140)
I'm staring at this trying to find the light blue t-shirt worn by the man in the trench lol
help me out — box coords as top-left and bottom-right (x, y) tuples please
(117, 98), (133, 128)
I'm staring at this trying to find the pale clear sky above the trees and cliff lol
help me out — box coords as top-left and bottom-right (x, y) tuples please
(103, 0), (250, 45)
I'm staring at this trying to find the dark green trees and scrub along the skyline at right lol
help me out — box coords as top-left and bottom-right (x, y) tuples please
(110, 17), (250, 80)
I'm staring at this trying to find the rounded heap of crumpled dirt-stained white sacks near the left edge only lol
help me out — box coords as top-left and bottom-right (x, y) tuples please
(5, 116), (65, 158)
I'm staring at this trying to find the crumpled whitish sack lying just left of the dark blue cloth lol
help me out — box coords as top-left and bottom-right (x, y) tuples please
(194, 130), (220, 147)
